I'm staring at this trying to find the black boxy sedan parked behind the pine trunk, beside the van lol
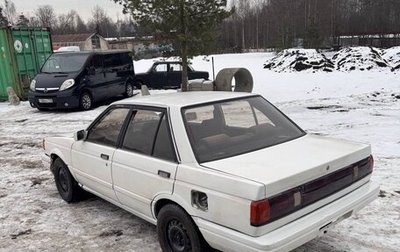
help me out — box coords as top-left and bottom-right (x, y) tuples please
(136, 61), (209, 89)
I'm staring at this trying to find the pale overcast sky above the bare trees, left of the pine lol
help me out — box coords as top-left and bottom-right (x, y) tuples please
(10, 0), (123, 21)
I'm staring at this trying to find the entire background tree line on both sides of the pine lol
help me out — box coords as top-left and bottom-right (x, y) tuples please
(0, 0), (400, 52)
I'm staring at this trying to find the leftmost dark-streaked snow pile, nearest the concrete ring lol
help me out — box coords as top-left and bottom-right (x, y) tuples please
(264, 49), (334, 72)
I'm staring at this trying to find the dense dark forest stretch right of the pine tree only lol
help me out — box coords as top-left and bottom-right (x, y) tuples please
(218, 0), (400, 51)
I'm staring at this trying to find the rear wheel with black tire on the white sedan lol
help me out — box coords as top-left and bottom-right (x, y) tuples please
(157, 204), (210, 252)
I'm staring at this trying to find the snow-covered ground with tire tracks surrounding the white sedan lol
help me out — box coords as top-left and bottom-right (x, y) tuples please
(0, 53), (400, 252)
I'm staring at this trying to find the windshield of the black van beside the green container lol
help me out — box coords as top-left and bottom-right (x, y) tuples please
(41, 53), (89, 73)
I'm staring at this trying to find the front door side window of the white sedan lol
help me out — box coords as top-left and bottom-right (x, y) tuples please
(87, 108), (129, 146)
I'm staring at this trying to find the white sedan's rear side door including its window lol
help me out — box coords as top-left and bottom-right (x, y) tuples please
(112, 108), (177, 218)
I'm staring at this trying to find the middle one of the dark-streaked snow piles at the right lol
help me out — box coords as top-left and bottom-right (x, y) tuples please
(332, 46), (390, 72)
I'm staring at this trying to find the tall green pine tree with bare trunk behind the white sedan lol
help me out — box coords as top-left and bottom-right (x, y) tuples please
(113, 0), (232, 91)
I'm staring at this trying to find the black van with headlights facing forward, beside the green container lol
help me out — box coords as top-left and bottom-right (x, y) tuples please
(28, 51), (135, 110)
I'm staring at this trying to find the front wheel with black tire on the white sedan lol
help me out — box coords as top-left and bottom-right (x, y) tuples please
(51, 158), (84, 203)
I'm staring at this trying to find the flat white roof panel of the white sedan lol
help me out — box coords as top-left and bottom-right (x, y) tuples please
(113, 91), (257, 108)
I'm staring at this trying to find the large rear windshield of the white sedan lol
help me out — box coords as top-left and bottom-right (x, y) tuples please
(182, 96), (305, 163)
